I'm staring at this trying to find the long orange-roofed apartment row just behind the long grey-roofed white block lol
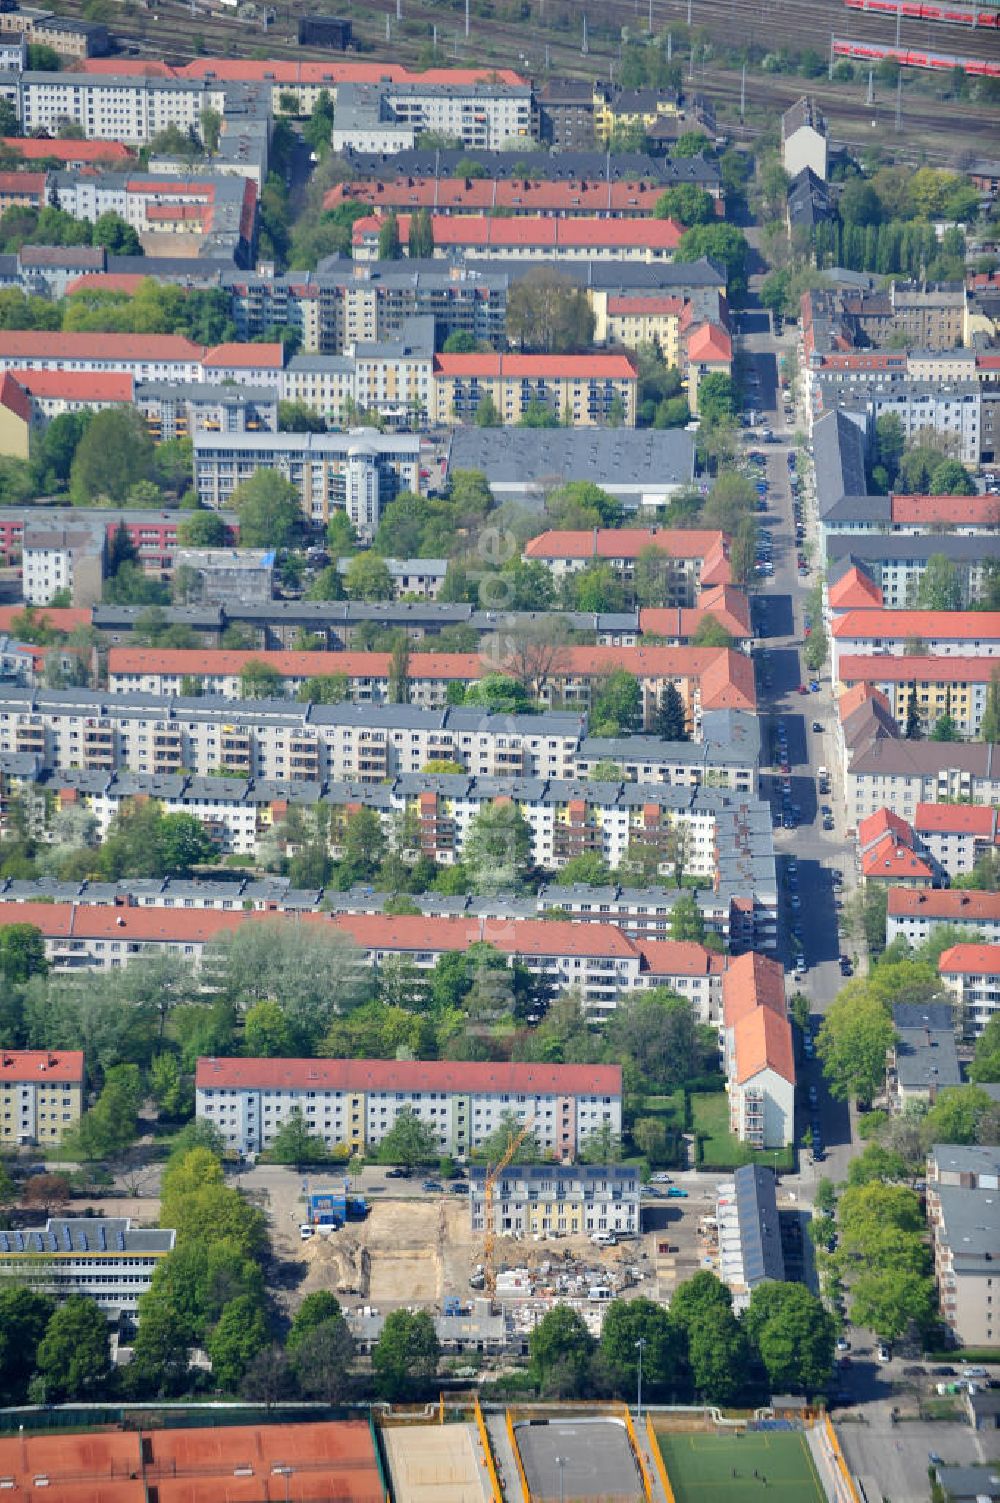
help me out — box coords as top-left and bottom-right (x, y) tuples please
(108, 645), (756, 735)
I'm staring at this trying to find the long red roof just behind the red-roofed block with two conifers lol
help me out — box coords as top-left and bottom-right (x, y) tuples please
(323, 176), (670, 216)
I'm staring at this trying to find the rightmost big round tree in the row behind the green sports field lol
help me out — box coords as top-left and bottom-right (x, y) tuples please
(743, 1282), (838, 1393)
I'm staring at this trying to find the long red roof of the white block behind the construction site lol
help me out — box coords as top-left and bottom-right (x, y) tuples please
(194, 1058), (621, 1096)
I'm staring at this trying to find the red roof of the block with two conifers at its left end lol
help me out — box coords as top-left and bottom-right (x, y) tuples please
(352, 213), (684, 251)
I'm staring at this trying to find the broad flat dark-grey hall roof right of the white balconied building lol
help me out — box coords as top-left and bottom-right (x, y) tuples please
(448, 427), (695, 493)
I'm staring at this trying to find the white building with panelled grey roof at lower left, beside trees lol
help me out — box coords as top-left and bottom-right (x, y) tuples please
(0, 1216), (177, 1326)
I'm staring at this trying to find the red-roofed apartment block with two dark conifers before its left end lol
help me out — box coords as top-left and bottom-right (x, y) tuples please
(350, 213), (684, 266)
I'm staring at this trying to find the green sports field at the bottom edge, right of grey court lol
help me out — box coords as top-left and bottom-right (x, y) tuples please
(656, 1431), (827, 1503)
